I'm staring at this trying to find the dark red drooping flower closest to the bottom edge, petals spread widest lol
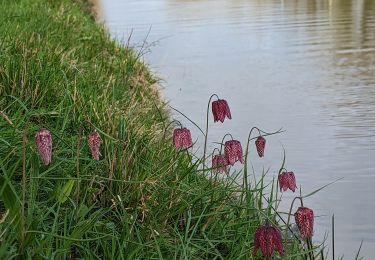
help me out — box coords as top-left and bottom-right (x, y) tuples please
(253, 223), (284, 259)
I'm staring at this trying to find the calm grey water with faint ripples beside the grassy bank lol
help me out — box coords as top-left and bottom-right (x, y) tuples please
(96, 0), (375, 259)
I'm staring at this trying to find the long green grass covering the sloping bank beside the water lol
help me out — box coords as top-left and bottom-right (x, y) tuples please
(0, 0), (324, 259)
